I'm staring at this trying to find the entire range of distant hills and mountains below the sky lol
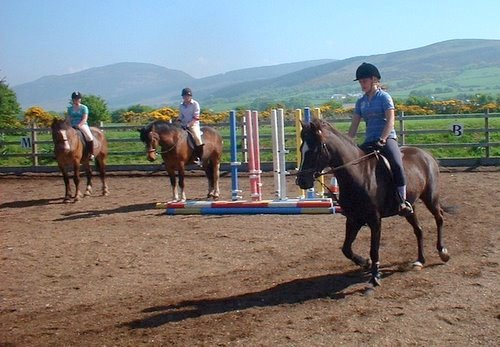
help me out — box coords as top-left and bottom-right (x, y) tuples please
(12, 39), (500, 111)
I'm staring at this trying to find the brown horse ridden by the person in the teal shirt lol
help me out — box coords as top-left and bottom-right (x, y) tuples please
(51, 119), (109, 203)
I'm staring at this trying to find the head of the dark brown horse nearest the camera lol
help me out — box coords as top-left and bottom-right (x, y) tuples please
(295, 119), (329, 189)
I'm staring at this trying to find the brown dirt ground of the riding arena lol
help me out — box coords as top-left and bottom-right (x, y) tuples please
(0, 170), (500, 346)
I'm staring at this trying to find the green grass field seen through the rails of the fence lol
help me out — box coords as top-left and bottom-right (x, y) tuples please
(0, 118), (500, 167)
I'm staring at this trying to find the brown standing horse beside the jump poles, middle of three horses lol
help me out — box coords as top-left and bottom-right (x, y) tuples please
(139, 121), (222, 201)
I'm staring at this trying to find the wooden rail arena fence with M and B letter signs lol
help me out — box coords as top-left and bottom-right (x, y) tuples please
(0, 112), (500, 174)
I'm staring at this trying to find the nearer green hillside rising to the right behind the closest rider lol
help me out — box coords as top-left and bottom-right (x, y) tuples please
(209, 40), (500, 102)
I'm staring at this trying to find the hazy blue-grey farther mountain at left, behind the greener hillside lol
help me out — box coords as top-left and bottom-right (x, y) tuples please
(12, 59), (332, 111)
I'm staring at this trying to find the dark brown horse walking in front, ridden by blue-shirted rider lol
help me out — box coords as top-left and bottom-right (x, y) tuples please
(296, 119), (450, 286)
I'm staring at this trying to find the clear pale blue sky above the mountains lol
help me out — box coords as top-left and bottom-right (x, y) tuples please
(0, 0), (500, 86)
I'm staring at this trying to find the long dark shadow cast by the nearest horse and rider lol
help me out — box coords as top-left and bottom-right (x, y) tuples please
(119, 269), (394, 329)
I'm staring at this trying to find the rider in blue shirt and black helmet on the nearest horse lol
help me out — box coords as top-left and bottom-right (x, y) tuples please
(348, 63), (413, 215)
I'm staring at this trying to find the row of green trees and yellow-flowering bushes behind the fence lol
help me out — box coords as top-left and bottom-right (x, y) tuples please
(0, 79), (500, 129)
